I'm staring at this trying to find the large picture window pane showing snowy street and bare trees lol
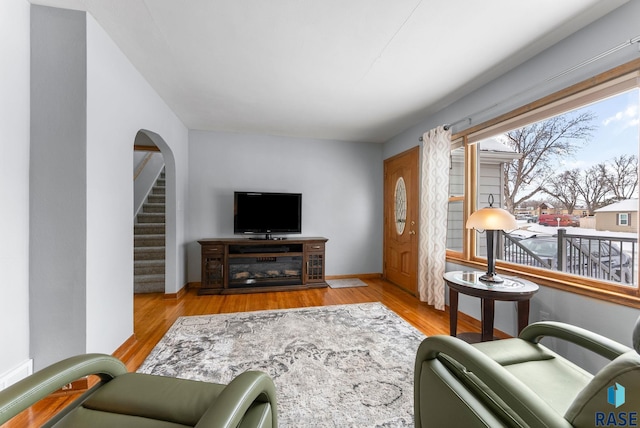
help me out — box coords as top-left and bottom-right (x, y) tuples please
(492, 89), (640, 289)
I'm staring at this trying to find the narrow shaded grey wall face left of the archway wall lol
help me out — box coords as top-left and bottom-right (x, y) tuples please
(29, 6), (87, 368)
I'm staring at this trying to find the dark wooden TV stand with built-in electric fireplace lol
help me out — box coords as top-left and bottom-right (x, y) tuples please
(198, 238), (327, 294)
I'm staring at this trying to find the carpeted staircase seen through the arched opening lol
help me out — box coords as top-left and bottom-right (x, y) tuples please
(133, 171), (166, 293)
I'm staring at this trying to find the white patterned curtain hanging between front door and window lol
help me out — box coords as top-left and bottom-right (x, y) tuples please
(418, 126), (451, 310)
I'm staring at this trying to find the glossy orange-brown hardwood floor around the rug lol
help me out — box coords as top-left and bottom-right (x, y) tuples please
(2, 278), (490, 428)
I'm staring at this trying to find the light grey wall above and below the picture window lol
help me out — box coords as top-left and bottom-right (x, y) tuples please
(390, 0), (640, 370)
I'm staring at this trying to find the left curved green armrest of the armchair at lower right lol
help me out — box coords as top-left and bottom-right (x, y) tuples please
(415, 335), (571, 428)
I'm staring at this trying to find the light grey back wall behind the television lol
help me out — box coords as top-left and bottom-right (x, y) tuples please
(187, 131), (383, 282)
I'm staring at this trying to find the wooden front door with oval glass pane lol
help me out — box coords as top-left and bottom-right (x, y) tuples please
(383, 147), (420, 295)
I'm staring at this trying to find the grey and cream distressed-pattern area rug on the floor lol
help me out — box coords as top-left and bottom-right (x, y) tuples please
(138, 303), (425, 428)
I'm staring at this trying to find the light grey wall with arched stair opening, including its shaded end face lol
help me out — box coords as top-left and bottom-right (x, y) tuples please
(30, 6), (188, 368)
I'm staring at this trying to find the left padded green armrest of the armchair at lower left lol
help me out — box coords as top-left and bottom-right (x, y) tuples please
(0, 354), (127, 425)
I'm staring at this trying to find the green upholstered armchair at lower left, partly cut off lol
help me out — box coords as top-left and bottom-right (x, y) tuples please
(0, 354), (277, 428)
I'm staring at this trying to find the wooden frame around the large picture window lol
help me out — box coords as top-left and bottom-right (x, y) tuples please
(447, 59), (640, 308)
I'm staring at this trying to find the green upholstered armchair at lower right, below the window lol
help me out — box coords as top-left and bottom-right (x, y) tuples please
(414, 318), (640, 428)
